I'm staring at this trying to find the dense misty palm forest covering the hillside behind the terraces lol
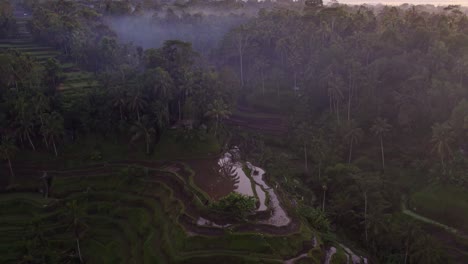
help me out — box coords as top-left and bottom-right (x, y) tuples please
(0, 0), (468, 263)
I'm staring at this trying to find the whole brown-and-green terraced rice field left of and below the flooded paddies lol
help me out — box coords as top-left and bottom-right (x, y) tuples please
(0, 163), (324, 263)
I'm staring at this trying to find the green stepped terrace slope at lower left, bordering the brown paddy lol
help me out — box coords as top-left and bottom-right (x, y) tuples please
(0, 164), (310, 263)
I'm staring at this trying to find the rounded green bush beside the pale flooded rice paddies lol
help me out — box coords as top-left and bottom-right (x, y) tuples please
(211, 192), (256, 219)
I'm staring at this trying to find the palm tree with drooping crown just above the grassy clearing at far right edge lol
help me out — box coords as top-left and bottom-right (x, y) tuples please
(431, 123), (454, 175)
